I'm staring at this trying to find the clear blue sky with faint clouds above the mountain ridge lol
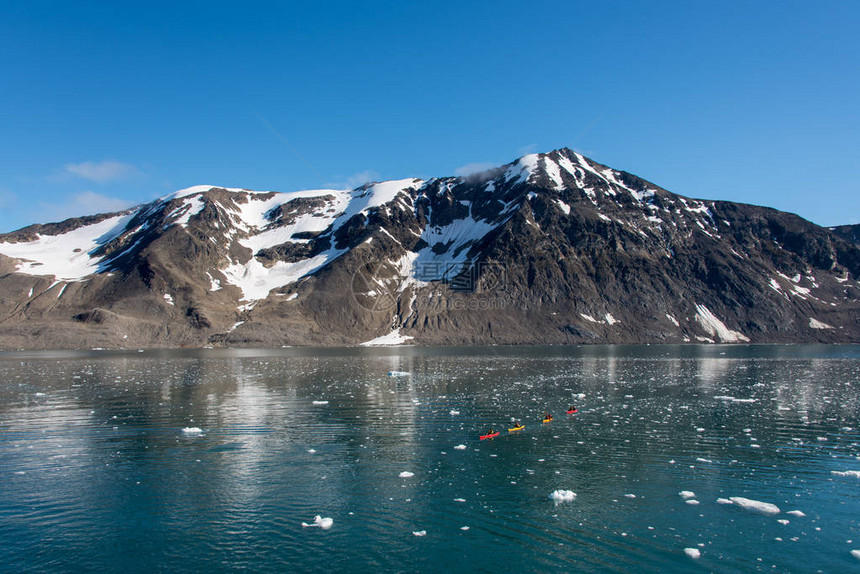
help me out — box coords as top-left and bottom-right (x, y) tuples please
(0, 1), (860, 231)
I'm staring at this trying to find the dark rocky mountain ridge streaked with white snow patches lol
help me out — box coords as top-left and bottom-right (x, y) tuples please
(0, 149), (860, 348)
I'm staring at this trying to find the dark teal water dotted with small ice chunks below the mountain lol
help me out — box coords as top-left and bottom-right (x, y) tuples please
(0, 345), (860, 572)
